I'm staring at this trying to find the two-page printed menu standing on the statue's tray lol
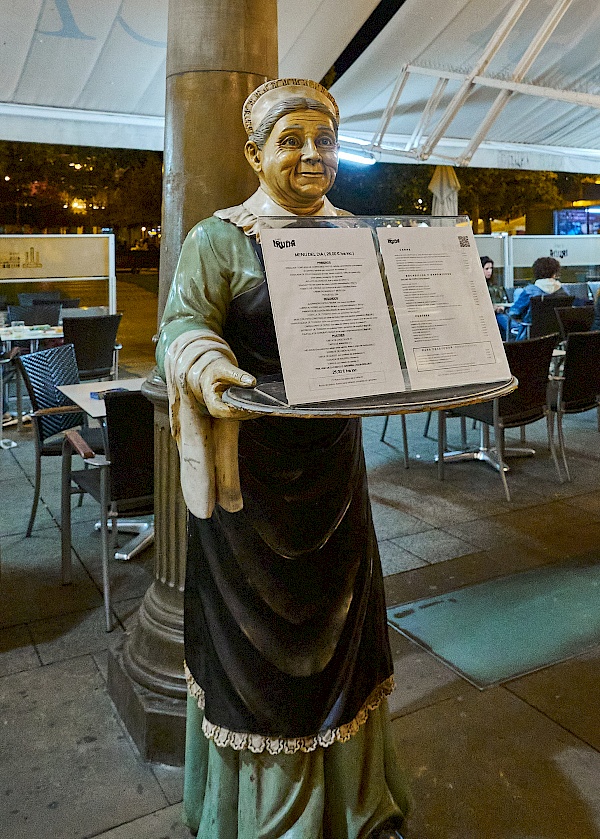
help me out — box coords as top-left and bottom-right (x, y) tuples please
(261, 219), (510, 405)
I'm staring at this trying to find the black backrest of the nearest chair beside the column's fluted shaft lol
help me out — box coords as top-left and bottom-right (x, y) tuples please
(104, 392), (155, 502)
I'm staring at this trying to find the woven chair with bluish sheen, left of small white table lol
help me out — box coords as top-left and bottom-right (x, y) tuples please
(14, 344), (104, 540)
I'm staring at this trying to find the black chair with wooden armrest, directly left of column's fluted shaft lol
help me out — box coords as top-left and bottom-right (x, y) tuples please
(61, 391), (154, 632)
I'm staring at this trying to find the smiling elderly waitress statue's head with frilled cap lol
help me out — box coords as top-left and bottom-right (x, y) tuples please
(243, 79), (339, 215)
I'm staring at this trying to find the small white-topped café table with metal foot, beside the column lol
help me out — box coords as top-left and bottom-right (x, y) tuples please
(58, 379), (154, 562)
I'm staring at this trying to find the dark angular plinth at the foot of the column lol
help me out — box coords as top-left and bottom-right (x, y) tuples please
(108, 642), (186, 766)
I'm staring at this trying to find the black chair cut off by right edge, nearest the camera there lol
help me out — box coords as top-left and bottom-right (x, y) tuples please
(548, 332), (600, 481)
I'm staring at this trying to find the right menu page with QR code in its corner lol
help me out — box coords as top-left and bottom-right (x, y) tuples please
(377, 227), (510, 390)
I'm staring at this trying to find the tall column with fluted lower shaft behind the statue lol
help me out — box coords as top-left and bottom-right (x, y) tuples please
(108, 0), (277, 764)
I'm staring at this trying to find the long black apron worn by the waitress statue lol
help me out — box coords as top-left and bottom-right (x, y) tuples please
(185, 246), (393, 738)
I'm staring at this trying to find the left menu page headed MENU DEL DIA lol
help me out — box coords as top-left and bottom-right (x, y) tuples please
(261, 226), (405, 405)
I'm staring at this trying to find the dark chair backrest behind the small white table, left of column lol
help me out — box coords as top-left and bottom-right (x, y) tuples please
(63, 312), (122, 381)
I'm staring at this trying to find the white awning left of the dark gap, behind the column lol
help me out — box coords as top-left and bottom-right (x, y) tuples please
(0, 0), (378, 149)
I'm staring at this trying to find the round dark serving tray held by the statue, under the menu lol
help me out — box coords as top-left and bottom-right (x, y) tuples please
(223, 376), (518, 419)
